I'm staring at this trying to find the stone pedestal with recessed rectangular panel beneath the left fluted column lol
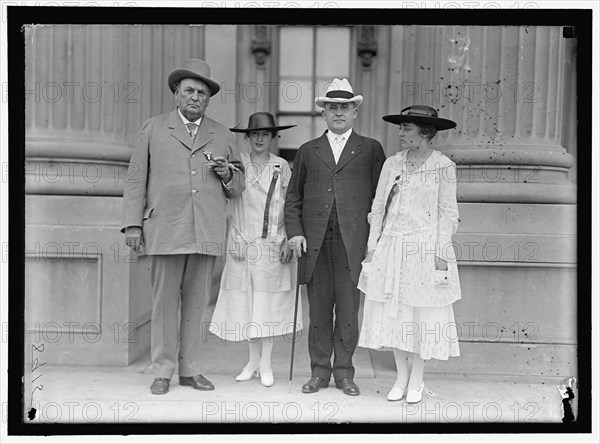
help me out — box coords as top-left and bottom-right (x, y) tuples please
(25, 195), (152, 366)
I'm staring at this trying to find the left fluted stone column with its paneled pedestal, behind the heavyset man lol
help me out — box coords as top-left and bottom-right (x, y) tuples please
(25, 25), (204, 365)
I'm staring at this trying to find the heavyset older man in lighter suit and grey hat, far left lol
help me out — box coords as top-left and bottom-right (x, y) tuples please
(122, 59), (245, 394)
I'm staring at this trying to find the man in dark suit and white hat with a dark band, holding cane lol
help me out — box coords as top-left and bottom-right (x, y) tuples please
(285, 79), (385, 396)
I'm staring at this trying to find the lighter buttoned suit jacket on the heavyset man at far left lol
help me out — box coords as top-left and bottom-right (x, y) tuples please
(121, 110), (246, 256)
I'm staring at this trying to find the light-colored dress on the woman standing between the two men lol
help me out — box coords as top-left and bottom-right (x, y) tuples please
(209, 153), (302, 341)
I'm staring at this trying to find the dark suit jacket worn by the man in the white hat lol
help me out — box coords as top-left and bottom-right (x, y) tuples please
(285, 131), (385, 284)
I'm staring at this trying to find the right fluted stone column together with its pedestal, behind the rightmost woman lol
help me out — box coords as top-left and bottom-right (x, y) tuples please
(386, 26), (576, 375)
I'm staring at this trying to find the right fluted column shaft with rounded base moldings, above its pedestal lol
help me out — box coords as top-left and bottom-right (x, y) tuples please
(387, 26), (575, 203)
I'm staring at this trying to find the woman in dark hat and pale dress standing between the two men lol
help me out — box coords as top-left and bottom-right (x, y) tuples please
(211, 112), (302, 387)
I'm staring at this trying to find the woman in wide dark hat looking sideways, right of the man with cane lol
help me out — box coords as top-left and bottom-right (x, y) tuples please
(358, 105), (461, 403)
